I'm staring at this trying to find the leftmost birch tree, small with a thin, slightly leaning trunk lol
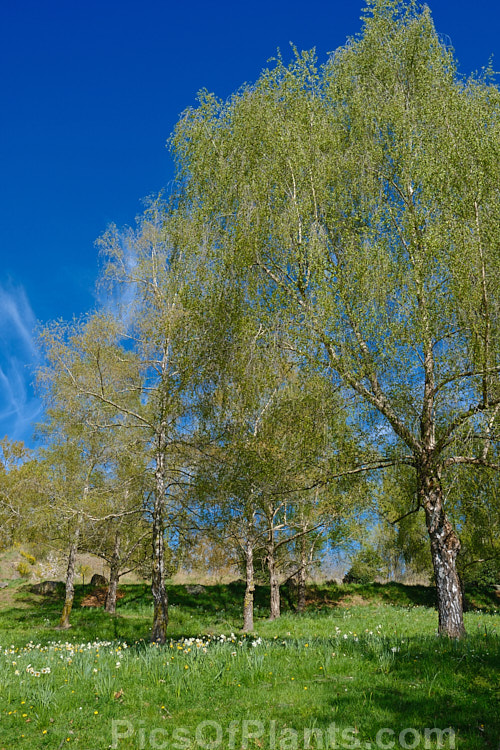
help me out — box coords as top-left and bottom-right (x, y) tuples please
(38, 358), (125, 629)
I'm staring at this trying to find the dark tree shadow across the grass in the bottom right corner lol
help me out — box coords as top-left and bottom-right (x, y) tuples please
(298, 635), (500, 750)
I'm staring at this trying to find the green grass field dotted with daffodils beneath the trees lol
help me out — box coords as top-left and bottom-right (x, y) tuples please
(0, 583), (500, 750)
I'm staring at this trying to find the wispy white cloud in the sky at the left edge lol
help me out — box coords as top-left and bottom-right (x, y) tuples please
(0, 284), (42, 440)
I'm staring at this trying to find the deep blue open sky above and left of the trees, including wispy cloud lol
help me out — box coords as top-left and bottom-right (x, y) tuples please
(0, 0), (500, 442)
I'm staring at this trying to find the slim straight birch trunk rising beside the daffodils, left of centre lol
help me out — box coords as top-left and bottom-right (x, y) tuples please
(151, 451), (168, 643)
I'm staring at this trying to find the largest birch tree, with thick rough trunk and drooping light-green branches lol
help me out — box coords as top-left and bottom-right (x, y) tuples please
(171, 0), (500, 637)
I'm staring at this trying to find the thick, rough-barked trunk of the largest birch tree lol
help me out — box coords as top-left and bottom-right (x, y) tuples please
(419, 467), (465, 638)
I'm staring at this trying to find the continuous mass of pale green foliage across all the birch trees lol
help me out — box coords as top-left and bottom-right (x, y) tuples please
(5, 0), (500, 640)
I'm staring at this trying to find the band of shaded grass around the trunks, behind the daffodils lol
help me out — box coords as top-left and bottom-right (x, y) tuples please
(0, 581), (496, 643)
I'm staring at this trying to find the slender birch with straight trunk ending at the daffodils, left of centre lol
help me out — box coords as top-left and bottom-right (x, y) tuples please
(40, 199), (207, 643)
